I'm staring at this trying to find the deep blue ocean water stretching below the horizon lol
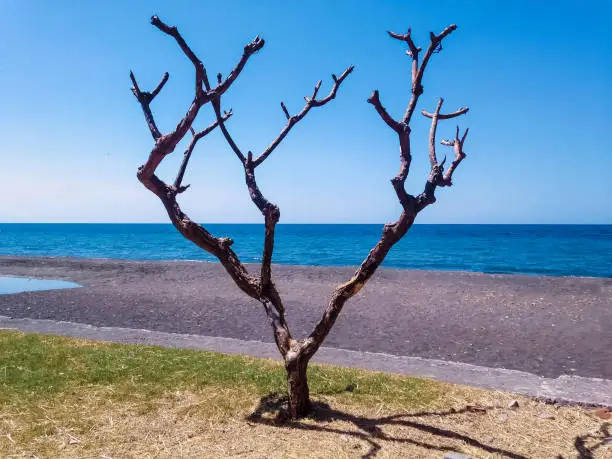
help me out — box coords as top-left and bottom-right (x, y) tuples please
(0, 223), (612, 277)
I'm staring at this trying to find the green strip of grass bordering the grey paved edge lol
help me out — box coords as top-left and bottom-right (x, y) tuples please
(0, 331), (442, 407)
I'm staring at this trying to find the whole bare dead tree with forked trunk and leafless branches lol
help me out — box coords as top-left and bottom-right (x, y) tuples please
(130, 16), (468, 418)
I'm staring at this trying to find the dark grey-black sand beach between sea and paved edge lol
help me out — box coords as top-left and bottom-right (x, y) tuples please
(0, 257), (612, 379)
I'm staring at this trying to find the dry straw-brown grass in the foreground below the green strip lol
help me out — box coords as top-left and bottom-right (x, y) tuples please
(0, 386), (612, 458)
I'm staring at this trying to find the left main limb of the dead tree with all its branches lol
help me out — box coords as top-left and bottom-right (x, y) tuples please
(130, 16), (353, 364)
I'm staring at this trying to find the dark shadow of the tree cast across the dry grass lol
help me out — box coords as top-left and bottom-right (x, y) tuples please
(247, 393), (526, 459)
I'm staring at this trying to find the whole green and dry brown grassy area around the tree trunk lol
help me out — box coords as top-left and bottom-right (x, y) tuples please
(0, 331), (610, 458)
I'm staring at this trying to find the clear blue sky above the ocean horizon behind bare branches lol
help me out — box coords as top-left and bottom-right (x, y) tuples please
(0, 0), (612, 223)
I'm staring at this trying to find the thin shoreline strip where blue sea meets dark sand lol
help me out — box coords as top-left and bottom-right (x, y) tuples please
(0, 254), (612, 280)
